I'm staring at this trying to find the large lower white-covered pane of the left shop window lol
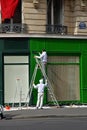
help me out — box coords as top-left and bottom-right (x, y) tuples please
(4, 65), (29, 103)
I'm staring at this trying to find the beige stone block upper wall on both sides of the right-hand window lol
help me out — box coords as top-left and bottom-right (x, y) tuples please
(22, 0), (87, 35)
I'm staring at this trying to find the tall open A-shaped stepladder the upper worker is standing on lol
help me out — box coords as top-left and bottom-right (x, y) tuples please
(26, 58), (59, 107)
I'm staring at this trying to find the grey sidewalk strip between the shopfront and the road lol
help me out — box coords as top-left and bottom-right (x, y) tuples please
(4, 105), (87, 119)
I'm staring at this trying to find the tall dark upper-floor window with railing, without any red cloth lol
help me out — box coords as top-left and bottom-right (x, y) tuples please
(46, 0), (67, 35)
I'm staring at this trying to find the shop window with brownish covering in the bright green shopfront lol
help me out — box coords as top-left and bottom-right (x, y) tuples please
(47, 56), (80, 101)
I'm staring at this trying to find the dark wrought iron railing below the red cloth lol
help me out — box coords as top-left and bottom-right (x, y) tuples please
(0, 23), (25, 33)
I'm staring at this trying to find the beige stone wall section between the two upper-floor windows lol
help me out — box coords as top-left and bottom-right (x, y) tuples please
(22, 0), (47, 33)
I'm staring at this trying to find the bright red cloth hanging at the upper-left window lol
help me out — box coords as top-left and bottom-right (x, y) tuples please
(1, 0), (19, 20)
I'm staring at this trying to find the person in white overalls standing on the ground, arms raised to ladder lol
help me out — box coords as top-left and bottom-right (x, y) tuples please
(33, 79), (47, 109)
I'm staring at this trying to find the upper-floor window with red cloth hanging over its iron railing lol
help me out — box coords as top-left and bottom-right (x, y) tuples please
(0, 0), (24, 33)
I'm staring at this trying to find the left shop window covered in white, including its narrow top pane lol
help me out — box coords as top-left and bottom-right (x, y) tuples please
(4, 55), (29, 105)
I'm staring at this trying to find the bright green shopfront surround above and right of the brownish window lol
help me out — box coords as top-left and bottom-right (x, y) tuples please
(30, 38), (87, 103)
